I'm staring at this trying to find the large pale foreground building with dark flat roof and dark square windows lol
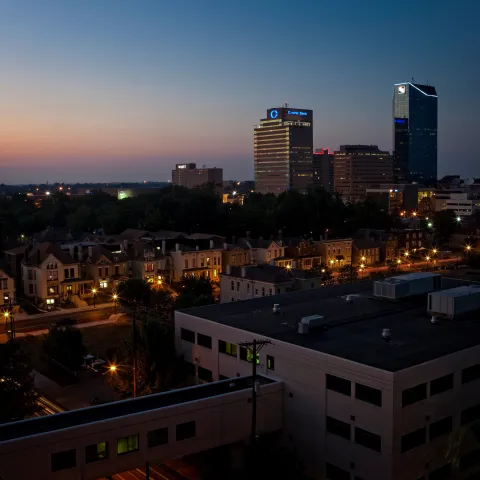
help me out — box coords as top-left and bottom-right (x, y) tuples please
(175, 276), (480, 480)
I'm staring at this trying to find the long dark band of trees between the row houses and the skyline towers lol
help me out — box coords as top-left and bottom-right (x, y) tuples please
(0, 186), (392, 243)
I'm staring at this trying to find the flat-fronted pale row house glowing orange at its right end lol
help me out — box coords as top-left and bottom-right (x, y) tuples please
(170, 240), (222, 282)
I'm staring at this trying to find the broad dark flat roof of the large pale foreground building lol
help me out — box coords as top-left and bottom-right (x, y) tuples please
(182, 278), (480, 372)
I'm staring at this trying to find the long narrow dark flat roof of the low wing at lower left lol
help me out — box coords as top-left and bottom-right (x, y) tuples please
(0, 375), (274, 442)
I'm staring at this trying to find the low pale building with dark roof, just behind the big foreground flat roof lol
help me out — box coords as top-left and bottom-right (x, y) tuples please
(220, 264), (321, 303)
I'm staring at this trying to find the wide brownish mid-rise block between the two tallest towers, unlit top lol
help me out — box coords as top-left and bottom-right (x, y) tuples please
(334, 145), (393, 202)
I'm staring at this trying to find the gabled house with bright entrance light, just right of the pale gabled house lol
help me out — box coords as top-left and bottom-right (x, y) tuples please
(85, 245), (129, 293)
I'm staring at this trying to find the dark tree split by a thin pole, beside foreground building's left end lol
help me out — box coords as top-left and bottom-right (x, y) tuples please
(107, 313), (187, 396)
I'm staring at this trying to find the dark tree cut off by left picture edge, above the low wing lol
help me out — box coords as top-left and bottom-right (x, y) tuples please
(0, 340), (38, 424)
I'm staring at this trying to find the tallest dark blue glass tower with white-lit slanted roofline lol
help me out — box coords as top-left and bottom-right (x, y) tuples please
(393, 82), (438, 185)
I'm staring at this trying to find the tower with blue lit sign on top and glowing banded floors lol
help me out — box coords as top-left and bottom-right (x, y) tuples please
(254, 105), (313, 194)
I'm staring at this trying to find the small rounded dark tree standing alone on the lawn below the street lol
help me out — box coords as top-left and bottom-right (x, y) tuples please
(42, 326), (87, 371)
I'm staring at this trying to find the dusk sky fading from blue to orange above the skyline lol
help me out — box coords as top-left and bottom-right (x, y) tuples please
(0, 0), (480, 184)
